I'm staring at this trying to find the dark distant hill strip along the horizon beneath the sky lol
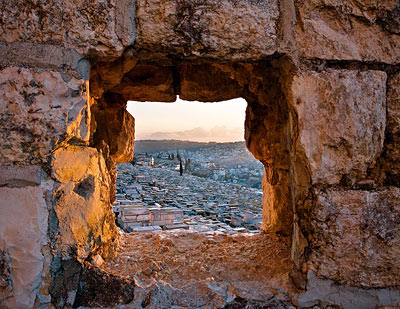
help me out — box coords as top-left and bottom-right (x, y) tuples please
(135, 140), (244, 153)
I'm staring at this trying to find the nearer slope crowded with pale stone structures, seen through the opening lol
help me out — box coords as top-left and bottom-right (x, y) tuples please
(113, 162), (262, 234)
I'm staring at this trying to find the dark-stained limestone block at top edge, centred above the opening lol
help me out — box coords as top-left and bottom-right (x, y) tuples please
(136, 0), (279, 60)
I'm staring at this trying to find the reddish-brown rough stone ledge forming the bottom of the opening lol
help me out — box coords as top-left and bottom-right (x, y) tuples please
(100, 231), (295, 307)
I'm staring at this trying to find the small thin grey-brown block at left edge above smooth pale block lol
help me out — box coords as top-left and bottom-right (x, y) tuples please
(0, 165), (41, 187)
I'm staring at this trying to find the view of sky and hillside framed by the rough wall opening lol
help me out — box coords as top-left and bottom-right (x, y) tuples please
(113, 97), (263, 235)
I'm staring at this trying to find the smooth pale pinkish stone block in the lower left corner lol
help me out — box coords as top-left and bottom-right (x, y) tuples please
(0, 186), (48, 308)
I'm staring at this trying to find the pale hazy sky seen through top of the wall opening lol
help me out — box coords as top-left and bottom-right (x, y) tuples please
(127, 98), (247, 142)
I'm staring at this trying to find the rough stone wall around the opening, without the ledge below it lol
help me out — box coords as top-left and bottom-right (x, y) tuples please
(0, 0), (400, 307)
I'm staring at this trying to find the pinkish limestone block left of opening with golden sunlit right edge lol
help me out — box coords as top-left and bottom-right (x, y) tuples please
(0, 67), (90, 165)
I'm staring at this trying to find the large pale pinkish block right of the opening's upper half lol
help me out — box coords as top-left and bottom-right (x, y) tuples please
(292, 69), (386, 184)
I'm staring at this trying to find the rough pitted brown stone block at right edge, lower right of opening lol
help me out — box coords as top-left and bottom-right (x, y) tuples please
(310, 187), (400, 287)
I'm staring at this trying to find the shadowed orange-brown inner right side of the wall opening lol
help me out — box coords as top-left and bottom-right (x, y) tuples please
(241, 65), (294, 235)
